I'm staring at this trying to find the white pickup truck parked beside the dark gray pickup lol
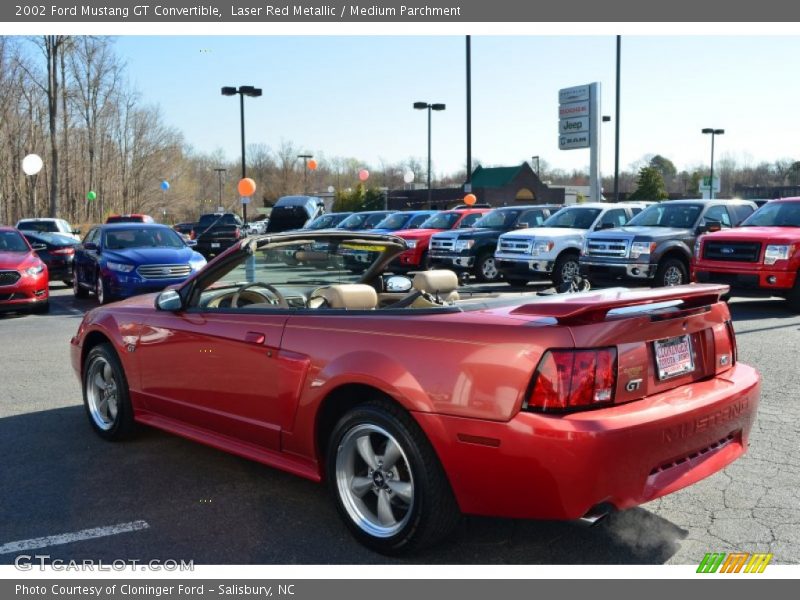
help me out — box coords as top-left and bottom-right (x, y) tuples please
(494, 202), (647, 287)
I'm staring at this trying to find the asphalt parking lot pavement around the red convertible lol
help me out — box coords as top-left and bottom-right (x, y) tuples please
(0, 284), (800, 564)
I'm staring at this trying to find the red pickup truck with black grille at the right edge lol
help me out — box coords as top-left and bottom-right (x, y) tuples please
(692, 198), (800, 311)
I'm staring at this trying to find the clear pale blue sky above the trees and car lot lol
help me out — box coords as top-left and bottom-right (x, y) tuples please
(116, 35), (800, 174)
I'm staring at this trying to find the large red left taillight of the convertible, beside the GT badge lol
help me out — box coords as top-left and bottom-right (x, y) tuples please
(525, 348), (617, 411)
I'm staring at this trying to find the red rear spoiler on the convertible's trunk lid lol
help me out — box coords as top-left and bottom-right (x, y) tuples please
(511, 284), (730, 325)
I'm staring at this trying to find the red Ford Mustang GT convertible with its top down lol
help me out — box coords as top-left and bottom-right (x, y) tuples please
(71, 231), (760, 553)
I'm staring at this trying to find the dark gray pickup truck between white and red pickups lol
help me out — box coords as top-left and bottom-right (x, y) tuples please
(580, 199), (756, 286)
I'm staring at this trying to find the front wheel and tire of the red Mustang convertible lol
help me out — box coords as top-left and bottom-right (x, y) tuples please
(81, 344), (134, 440)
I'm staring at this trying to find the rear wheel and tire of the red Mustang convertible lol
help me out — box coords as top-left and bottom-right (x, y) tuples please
(326, 400), (461, 555)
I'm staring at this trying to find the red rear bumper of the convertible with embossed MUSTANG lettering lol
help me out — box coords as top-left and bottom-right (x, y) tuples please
(414, 364), (760, 519)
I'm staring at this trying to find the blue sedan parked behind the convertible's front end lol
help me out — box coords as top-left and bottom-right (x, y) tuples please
(72, 223), (206, 304)
